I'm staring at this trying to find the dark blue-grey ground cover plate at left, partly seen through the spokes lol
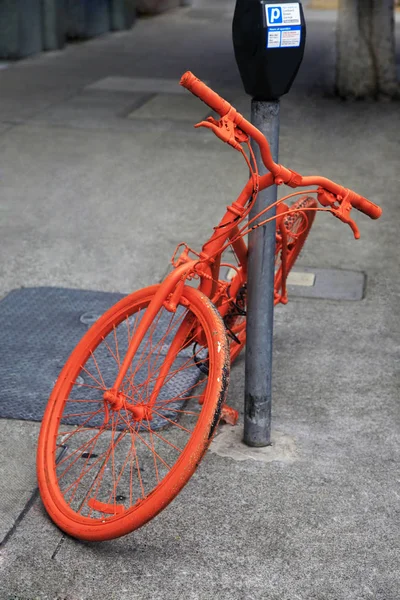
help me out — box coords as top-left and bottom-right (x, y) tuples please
(0, 287), (203, 429)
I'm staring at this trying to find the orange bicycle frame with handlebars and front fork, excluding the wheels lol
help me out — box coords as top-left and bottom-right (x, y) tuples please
(105, 72), (382, 406)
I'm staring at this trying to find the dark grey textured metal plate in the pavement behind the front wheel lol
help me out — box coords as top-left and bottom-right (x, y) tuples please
(0, 287), (200, 429)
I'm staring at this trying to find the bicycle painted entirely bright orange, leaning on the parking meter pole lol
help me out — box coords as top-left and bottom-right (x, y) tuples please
(37, 72), (381, 540)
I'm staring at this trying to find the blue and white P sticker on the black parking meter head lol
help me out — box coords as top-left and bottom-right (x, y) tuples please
(265, 2), (301, 48)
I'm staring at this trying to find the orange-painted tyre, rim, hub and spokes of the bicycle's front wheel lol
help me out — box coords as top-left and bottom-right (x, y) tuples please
(37, 284), (233, 541)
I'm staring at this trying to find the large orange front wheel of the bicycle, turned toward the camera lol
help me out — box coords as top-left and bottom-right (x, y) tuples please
(37, 285), (229, 540)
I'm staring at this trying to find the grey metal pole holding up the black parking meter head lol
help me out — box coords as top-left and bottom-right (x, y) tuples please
(243, 100), (279, 446)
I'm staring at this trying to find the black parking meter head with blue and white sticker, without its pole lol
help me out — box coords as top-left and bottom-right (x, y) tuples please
(232, 0), (306, 100)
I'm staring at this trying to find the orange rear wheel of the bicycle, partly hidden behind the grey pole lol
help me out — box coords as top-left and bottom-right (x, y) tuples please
(225, 196), (318, 363)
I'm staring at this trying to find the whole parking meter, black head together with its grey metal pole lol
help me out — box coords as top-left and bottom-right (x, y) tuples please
(232, 0), (306, 446)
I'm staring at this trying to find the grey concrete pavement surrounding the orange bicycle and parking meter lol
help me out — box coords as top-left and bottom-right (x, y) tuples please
(0, 0), (400, 600)
